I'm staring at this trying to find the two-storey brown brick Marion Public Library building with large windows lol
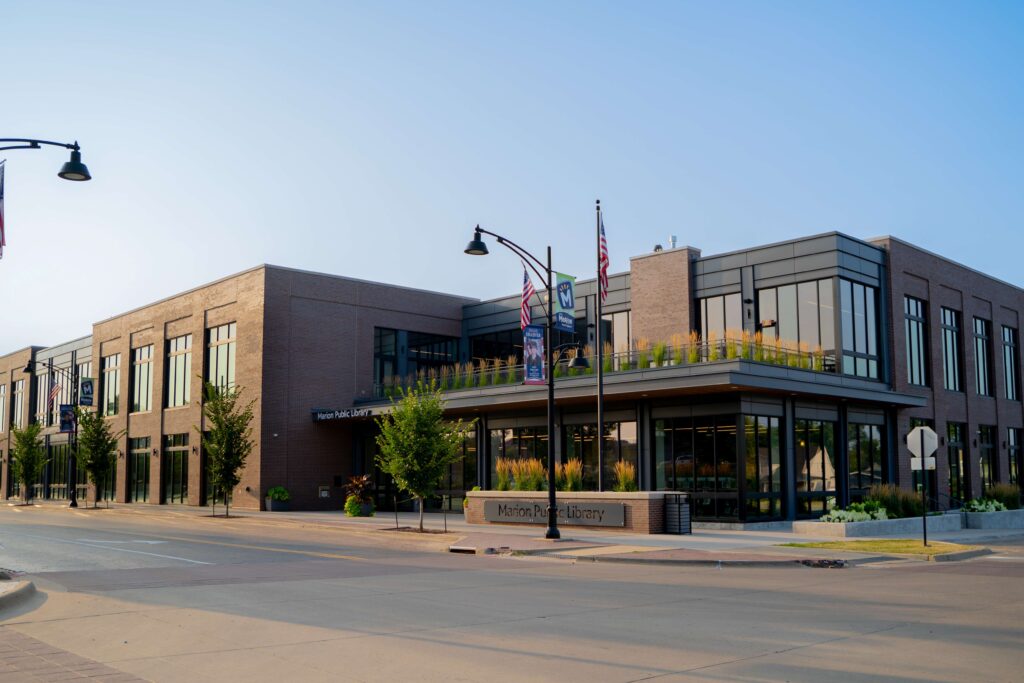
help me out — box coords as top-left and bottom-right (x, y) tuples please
(0, 232), (1024, 521)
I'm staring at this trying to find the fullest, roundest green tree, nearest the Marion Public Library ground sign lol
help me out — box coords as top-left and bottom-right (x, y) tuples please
(377, 382), (472, 531)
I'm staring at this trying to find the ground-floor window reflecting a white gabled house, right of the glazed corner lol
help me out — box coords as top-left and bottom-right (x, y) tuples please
(794, 420), (836, 517)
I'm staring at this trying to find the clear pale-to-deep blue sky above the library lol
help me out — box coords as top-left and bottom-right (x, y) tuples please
(0, 0), (1024, 353)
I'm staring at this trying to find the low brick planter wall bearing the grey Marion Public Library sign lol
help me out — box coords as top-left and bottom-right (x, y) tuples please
(466, 490), (665, 533)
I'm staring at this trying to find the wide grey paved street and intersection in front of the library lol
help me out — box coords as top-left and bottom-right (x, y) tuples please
(0, 508), (1024, 682)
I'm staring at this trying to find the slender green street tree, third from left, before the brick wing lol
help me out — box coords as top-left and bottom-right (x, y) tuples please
(197, 382), (256, 517)
